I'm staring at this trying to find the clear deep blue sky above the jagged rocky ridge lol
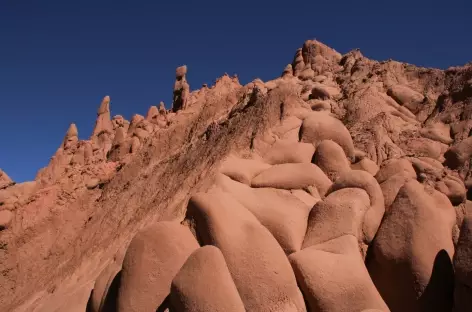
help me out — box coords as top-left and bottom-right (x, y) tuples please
(0, 0), (472, 182)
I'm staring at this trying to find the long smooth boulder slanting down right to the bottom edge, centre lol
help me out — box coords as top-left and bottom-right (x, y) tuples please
(187, 188), (306, 312)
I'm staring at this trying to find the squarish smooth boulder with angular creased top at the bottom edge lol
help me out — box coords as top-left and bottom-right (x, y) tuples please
(289, 235), (389, 312)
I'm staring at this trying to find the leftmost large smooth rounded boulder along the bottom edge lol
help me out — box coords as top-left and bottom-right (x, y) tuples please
(117, 221), (199, 312)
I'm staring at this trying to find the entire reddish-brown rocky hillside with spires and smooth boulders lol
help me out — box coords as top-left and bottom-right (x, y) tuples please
(0, 40), (472, 312)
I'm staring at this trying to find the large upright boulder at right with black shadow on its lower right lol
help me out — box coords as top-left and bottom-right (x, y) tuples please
(367, 180), (456, 312)
